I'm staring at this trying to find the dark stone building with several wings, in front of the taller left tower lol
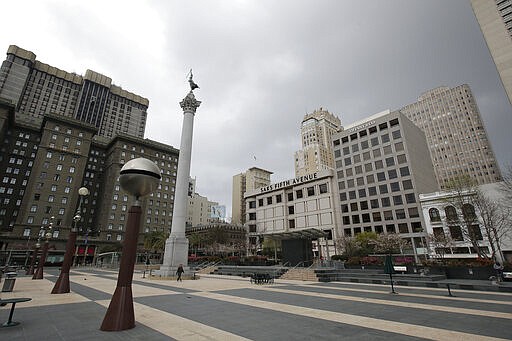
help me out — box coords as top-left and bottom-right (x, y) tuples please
(0, 100), (179, 262)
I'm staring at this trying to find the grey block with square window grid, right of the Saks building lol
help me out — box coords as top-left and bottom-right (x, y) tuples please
(333, 111), (438, 255)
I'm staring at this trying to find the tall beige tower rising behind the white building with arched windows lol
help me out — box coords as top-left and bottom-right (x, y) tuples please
(400, 84), (501, 188)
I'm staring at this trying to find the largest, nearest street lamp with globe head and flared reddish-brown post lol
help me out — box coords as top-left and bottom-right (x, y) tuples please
(100, 158), (161, 331)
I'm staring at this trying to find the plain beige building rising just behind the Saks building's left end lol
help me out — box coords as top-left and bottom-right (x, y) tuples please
(231, 167), (272, 225)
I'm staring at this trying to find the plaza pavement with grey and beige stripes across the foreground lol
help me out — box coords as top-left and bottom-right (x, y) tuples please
(0, 268), (512, 341)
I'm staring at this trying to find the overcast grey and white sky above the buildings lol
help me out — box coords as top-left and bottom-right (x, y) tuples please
(0, 0), (512, 215)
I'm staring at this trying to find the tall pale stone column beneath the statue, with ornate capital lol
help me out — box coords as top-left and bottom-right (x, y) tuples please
(159, 90), (201, 277)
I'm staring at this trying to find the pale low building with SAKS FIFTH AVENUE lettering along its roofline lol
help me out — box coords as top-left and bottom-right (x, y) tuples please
(245, 170), (341, 265)
